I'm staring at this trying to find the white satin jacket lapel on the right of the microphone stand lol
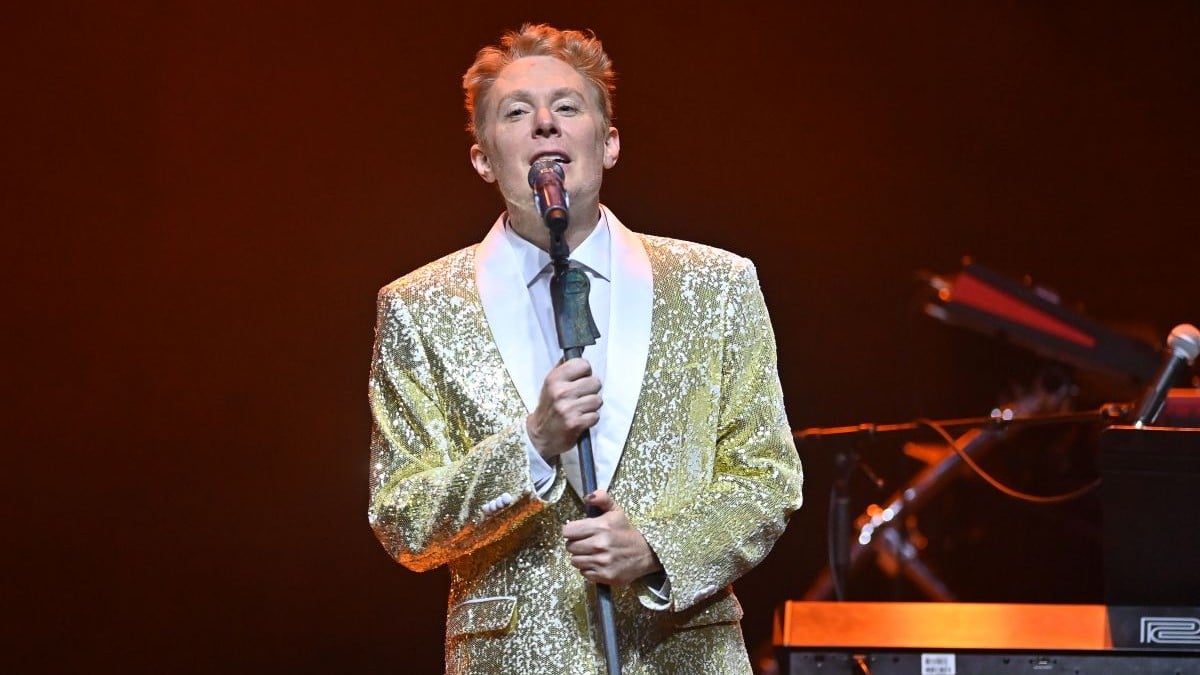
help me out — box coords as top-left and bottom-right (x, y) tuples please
(596, 201), (654, 489)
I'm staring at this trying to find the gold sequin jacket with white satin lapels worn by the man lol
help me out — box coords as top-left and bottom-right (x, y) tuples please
(370, 210), (803, 675)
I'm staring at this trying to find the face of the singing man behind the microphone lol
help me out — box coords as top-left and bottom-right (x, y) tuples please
(470, 56), (620, 217)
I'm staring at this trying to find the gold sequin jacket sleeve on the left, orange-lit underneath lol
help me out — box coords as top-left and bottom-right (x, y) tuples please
(368, 286), (565, 572)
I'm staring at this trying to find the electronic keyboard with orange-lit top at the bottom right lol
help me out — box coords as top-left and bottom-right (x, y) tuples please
(774, 601), (1200, 675)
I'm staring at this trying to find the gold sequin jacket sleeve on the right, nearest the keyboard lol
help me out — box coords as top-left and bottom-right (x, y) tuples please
(632, 259), (803, 611)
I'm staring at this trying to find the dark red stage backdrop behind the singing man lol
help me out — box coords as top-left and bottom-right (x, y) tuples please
(9, 1), (1200, 673)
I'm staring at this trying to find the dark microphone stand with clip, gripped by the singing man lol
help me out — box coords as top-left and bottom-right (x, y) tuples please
(544, 224), (620, 675)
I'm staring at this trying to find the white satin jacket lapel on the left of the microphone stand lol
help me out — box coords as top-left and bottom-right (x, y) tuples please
(475, 214), (553, 412)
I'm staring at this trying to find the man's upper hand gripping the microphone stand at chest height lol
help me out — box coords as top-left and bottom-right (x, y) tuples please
(526, 358), (604, 461)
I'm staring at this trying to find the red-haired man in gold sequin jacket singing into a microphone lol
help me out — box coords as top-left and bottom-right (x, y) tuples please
(360, 25), (802, 675)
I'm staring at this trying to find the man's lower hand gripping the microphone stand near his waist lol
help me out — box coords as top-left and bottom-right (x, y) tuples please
(563, 490), (662, 586)
